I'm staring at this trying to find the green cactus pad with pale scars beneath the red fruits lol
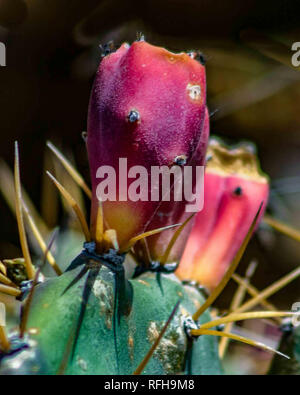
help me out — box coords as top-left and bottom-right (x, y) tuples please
(22, 266), (222, 375)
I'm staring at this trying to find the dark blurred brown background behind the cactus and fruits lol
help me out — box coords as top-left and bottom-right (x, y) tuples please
(0, 0), (300, 316)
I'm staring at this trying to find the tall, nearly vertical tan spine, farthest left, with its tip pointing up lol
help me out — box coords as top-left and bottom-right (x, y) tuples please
(15, 141), (34, 280)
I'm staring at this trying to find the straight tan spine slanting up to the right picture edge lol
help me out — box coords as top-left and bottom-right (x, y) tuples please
(235, 266), (300, 313)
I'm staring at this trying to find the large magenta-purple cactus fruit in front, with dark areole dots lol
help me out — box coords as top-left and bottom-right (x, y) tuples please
(87, 41), (208, 262)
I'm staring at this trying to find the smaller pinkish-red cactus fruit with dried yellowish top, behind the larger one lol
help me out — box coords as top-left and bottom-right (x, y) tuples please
(176, 140), (269, 289)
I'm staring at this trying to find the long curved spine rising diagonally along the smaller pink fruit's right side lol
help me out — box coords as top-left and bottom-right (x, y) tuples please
(193, 202), (263, 321)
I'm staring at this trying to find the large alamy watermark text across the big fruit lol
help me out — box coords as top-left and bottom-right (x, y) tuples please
(96, 158), (204, 213)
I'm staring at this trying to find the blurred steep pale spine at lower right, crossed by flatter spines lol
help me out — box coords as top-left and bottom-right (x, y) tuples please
(219, 261), (257, 359)
